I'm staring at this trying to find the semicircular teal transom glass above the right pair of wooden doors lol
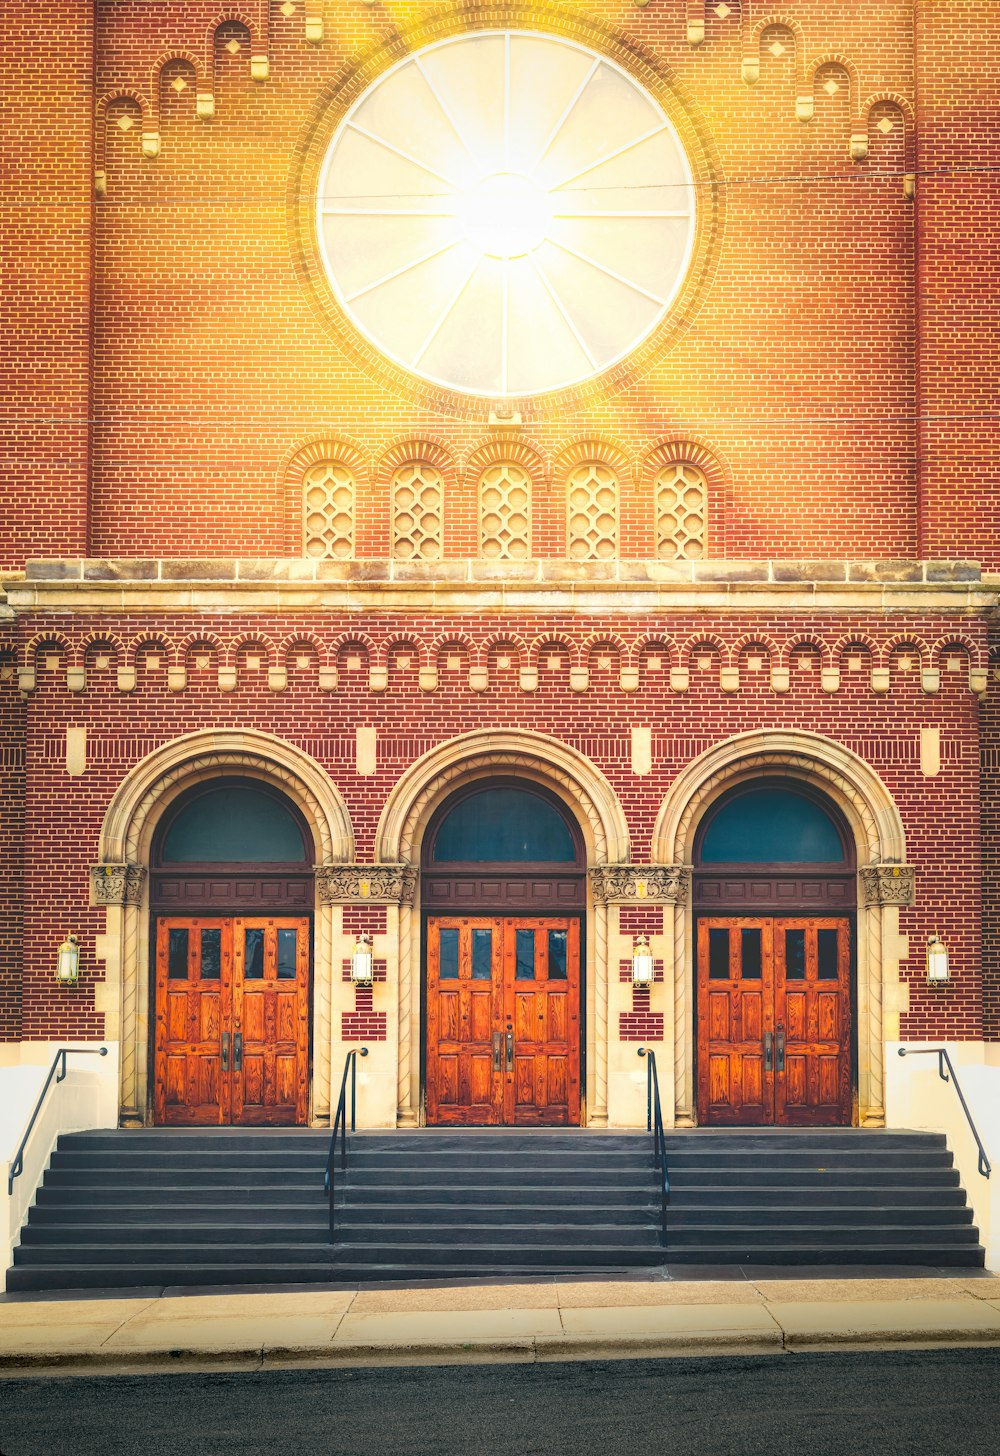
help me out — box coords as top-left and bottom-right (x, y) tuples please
(696, 785), (847, 865)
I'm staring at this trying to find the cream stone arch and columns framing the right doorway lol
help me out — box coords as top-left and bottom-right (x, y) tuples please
(651, 729), (914, 1127)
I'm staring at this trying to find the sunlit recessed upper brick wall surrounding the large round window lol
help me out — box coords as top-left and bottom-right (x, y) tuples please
(35, 0), (931, 558)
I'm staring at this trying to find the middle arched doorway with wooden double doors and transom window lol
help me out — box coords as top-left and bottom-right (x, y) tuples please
(422, 779), (587, 1127)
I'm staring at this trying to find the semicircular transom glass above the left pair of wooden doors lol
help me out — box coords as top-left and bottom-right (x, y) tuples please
(163, 783), (306, 865)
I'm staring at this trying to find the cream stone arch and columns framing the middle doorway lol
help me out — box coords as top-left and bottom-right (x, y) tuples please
(376, 729), (629, 1127)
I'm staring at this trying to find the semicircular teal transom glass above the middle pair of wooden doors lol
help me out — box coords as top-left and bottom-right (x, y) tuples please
(432, 788), (576, 865)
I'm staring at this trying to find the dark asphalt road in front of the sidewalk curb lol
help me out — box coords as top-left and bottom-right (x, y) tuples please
(0, 1350), (1000, 1456)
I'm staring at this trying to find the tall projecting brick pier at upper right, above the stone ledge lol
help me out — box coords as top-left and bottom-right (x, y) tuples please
(916, 0), (1000, 571)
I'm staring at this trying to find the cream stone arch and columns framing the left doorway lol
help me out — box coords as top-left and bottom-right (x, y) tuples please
(92, 729), (354, 1124)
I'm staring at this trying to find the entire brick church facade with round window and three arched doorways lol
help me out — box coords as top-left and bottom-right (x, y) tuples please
(0, 0), (1000, 1127)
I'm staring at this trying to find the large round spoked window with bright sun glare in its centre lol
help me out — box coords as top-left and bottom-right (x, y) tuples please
(319, 31), (694, 396)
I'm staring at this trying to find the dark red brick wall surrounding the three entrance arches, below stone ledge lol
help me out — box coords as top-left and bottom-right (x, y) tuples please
(9, 616), (996, 1038)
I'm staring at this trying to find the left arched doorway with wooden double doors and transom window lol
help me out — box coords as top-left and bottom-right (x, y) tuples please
(150, 778), (314, 1125)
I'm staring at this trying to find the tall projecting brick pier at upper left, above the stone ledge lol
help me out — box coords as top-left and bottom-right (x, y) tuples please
(0, 0), (93, 569)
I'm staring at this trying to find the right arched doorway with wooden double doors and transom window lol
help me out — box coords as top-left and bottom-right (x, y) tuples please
(693, 778), (856, 1127)
